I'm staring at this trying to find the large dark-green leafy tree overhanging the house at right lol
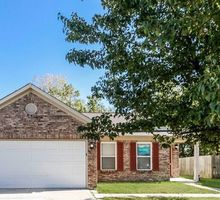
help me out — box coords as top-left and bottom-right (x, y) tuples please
(59, 0), (220, 144)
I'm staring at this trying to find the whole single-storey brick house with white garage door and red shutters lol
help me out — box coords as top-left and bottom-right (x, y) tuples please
(0, 84), (179, 188)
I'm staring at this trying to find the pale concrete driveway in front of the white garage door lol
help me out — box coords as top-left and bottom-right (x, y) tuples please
(0, 189), (94, 200)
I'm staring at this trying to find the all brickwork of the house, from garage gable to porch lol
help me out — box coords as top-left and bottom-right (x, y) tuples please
(0, 93), (178, 188)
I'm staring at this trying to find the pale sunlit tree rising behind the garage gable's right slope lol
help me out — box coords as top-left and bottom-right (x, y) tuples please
(34, 74), (86, 112)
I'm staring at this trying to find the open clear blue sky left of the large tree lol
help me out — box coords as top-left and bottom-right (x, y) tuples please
(0, 0), (103, 99)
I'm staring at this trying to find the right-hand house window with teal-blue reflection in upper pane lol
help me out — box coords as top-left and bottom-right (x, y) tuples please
(137, 142), (152, 170)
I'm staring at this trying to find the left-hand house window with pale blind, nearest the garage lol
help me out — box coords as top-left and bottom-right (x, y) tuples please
(101, 142), (116, 170)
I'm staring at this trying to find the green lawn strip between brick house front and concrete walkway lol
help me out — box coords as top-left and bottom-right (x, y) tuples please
(96, 181), (217, 194)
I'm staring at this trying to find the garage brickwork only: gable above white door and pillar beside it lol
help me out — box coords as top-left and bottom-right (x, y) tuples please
(0, 93), (97, 188)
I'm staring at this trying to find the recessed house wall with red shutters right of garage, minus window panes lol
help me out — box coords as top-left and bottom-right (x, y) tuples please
(97, 139), (179, 182)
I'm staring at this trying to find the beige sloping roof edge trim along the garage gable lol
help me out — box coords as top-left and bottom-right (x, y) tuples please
(0, 83), (91, 123)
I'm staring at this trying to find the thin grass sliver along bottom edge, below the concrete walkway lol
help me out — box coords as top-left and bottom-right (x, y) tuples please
(104, 198), (219, 200)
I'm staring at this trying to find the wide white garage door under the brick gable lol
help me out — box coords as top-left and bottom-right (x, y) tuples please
(0, 141), (86, 188)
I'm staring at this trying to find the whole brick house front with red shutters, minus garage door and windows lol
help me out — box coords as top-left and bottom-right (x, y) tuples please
(0, 85), (179, 188)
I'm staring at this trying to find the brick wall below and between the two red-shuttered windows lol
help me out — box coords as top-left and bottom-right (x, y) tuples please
(98, 141), (170, 182)
